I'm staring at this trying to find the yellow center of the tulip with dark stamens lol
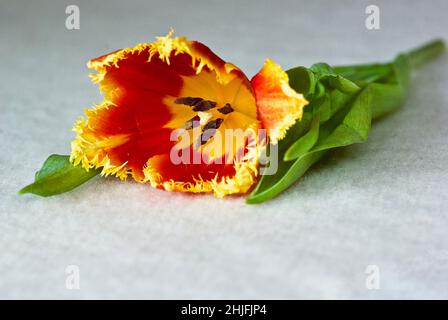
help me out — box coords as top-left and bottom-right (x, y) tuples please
(163, 70), (258, 159)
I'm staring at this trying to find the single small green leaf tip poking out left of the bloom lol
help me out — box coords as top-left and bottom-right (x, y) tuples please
(19, 154), (100, 197)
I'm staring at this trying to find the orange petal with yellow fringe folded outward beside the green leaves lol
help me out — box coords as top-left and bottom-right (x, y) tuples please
(251, 59), (308, 144)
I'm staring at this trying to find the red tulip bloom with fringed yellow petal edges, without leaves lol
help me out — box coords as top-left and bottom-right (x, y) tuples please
(71, 32), (307, 197)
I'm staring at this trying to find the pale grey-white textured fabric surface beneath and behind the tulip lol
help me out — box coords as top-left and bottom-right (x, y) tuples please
(0, 0), (448, 299)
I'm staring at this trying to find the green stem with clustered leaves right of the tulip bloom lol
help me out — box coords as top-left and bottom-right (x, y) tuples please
(246, 41), (444, 204)
